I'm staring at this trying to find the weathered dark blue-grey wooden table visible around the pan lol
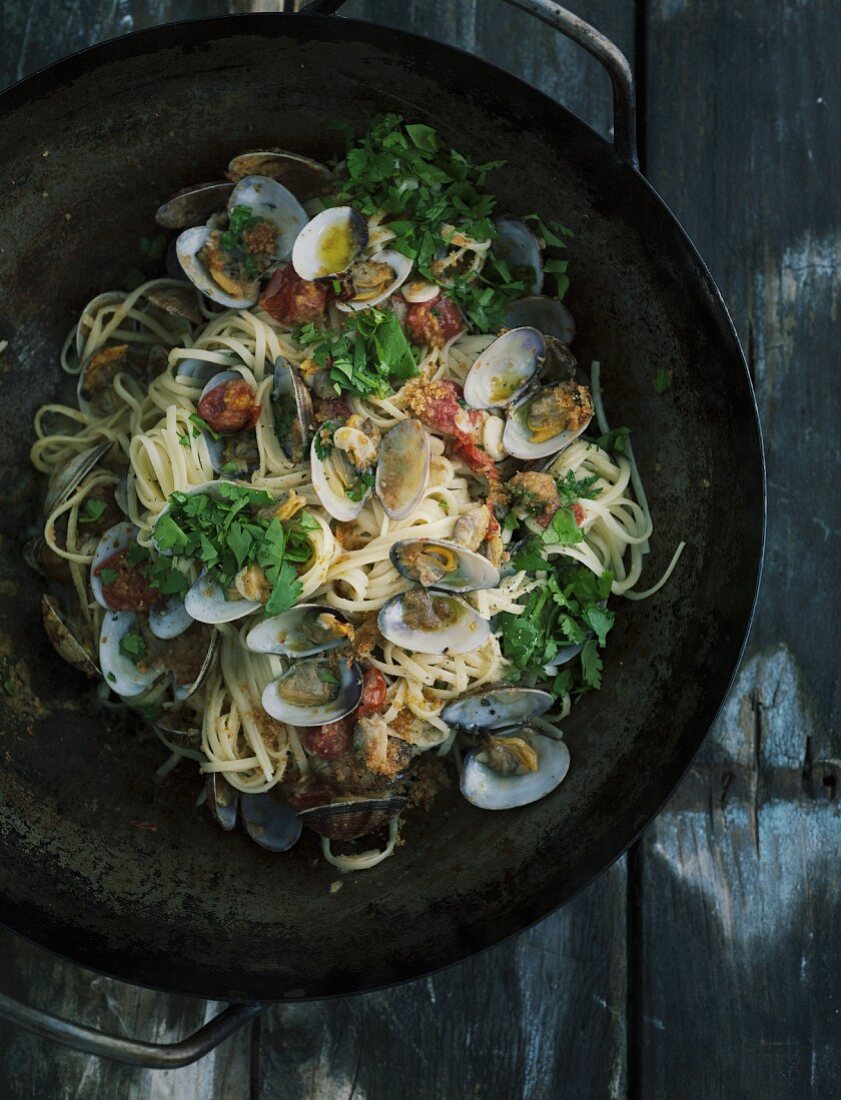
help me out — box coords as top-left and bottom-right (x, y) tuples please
(0, 0), (841, 1100)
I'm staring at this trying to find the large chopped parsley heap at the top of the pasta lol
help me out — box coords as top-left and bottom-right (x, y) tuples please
(330, 114), (569, 332)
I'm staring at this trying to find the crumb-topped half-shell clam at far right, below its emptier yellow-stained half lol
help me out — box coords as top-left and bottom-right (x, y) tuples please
(502, 382), (594, 460)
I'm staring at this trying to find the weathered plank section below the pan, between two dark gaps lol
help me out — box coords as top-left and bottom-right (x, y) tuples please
(259, 862), (627, 1100)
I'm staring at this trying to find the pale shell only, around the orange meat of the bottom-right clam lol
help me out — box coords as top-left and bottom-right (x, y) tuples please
(460, 726), (569, 810)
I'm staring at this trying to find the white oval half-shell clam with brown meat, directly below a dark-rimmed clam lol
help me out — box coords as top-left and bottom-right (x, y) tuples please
(377, 589), (490, 653)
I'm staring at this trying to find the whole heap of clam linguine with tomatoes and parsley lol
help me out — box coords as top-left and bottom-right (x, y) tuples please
(27, 116), (682, 870)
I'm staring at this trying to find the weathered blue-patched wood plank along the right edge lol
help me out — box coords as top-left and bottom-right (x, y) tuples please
(630, 0), (841, 1100)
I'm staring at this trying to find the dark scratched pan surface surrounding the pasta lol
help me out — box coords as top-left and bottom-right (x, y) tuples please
(0, 15), (764, 999)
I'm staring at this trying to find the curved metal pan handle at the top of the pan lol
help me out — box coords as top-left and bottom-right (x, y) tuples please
(301, 0), (640, 168)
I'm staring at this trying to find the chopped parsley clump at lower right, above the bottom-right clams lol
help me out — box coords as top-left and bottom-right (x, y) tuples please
(498, 559), (613, 694)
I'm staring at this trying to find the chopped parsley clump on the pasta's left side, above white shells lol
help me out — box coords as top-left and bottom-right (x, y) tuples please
(147, 483), (318, 615)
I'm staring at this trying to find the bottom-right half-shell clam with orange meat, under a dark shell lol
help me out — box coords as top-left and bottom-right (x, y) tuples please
(460, 726), (569, 810)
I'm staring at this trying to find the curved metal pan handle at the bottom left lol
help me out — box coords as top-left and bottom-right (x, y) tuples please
(0, 993), (263, 1069)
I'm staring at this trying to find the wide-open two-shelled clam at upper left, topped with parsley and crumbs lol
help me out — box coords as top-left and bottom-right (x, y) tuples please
(176, 176), (307, 309)
